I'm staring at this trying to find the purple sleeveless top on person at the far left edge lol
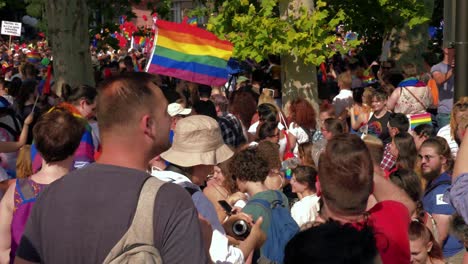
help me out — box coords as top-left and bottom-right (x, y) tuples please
(10, 178), (47, 263)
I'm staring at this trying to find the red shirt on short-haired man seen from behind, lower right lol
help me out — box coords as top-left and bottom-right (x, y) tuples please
(353, 201), (411, 264)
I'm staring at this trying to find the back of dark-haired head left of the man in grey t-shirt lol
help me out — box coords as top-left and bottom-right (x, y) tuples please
(33, 108), (85, 163)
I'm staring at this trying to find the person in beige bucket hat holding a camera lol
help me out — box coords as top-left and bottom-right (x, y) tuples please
(152, 115), (265, 263)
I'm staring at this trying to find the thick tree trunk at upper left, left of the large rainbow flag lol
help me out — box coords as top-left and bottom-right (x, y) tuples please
(46, 0), (95, 95)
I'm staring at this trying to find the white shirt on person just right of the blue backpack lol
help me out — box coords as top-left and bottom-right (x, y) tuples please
(291, 194), (319, 226)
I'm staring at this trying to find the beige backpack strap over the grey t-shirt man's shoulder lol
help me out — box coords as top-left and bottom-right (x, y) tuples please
(104, 177), (165, 263)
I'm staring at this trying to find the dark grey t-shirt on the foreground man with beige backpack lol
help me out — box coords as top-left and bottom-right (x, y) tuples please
(17, 164), (207, 264)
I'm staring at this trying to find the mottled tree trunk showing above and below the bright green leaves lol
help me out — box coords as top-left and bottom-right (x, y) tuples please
(280, 0), (318, 116)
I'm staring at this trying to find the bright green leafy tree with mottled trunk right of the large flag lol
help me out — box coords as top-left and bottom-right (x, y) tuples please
(207, 0), (344, 109)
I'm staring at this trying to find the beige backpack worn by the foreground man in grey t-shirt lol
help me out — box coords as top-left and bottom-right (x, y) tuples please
(103, 177), (164, 264)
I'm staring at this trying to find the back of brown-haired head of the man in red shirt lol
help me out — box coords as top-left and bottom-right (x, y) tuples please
(318, 134), (373, 215)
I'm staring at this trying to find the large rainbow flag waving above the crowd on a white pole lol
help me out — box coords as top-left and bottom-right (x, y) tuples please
(146, 19), (233, 86)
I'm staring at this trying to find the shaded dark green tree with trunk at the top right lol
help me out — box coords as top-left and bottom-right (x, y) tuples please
(326, 0), (434, 67)
